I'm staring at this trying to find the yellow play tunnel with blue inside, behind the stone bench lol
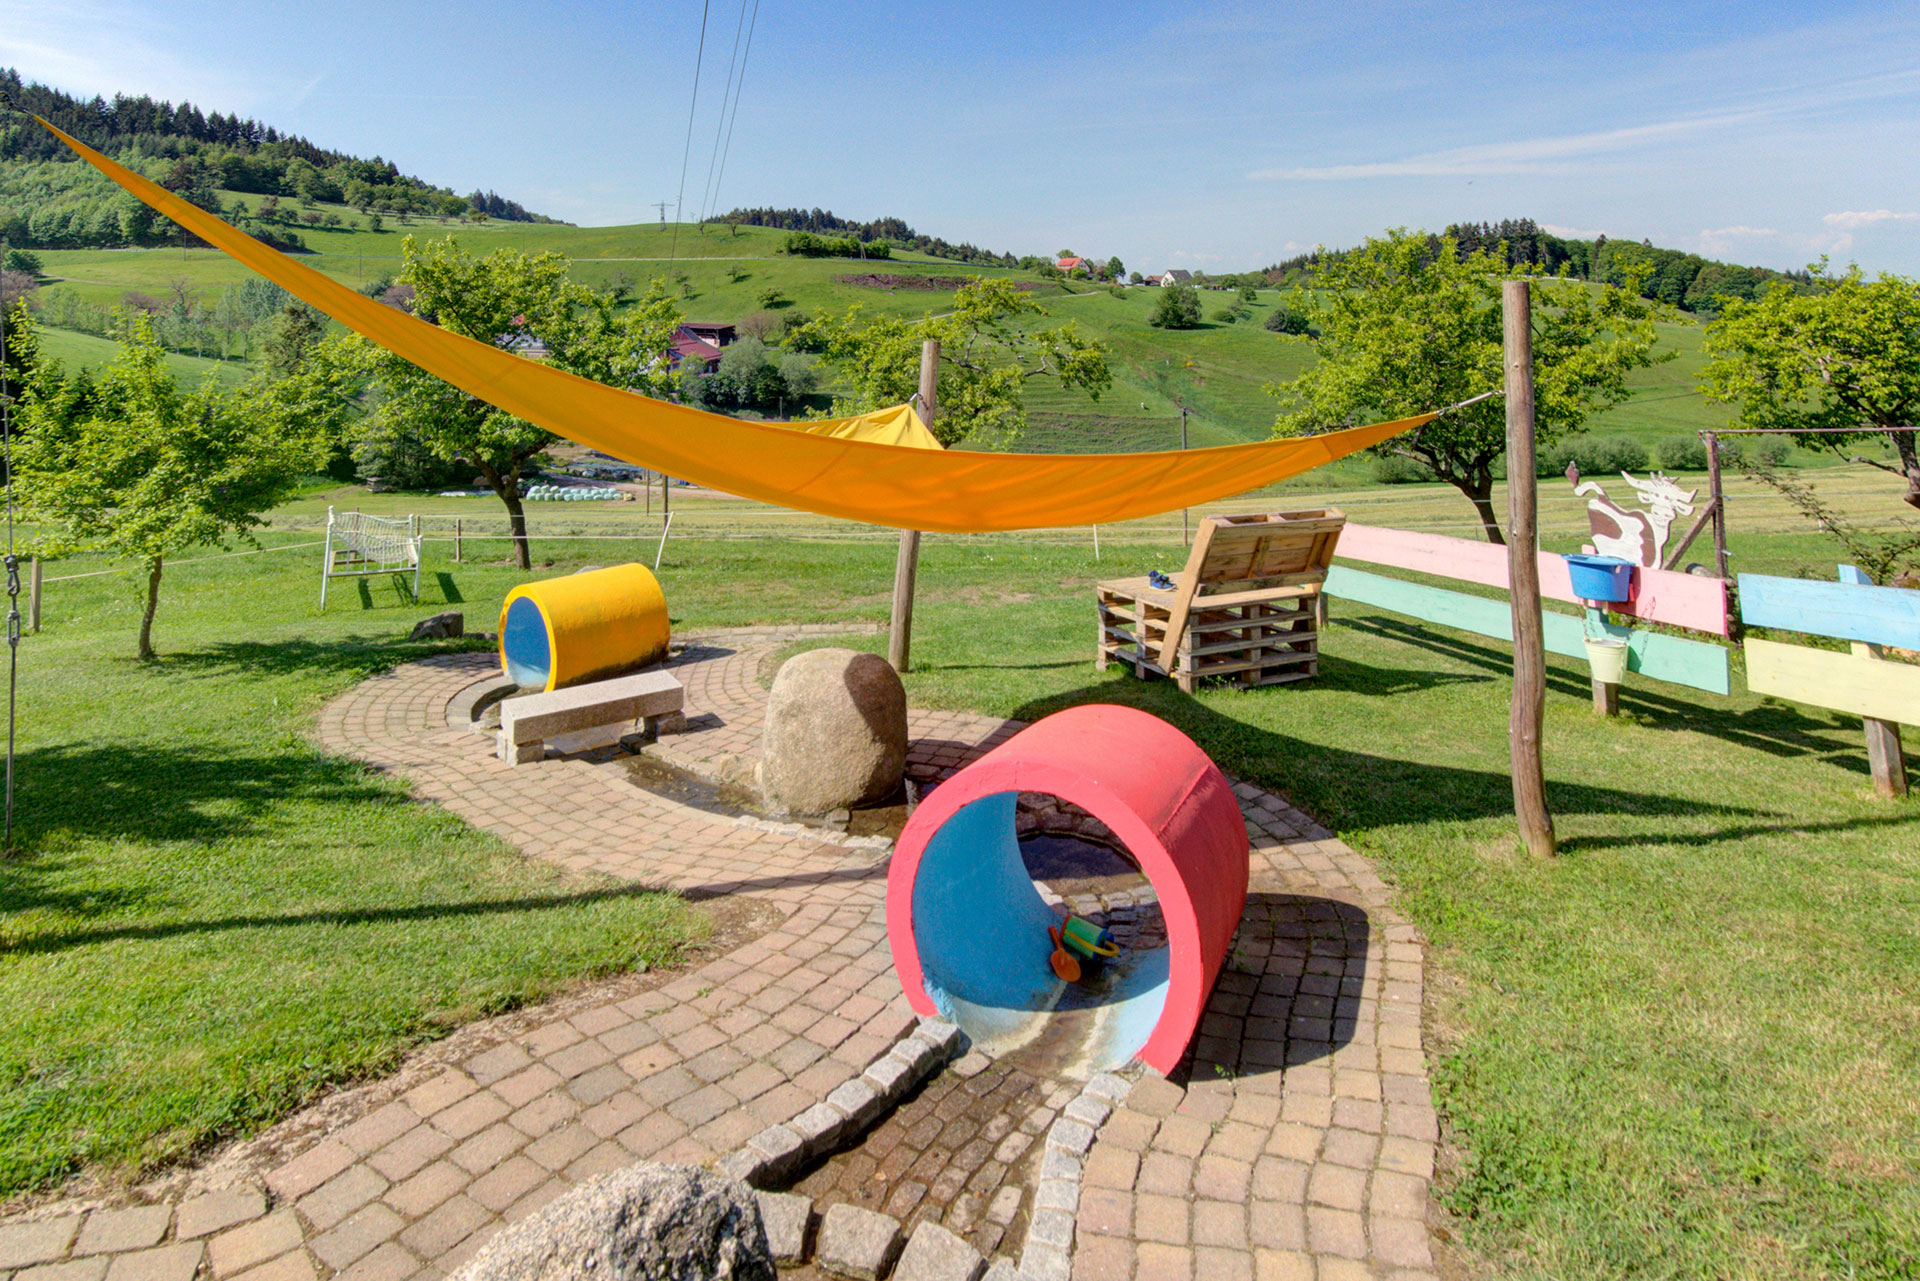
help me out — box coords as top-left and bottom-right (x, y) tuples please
(499, 565), (668, 689)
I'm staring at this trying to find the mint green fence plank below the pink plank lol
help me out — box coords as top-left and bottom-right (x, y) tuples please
(1325, 565), (1732, 693)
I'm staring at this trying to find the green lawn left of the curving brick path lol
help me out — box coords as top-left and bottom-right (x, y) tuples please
(0, 530), (705, 1198)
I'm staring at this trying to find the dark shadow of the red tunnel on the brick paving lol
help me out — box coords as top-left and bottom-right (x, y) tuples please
(1171, 891), (1373, 1085)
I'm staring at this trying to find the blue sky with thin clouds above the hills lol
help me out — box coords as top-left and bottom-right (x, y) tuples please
(0, 0), (1920, 275)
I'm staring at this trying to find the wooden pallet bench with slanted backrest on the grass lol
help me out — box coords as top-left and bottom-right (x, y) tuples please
(1094, 507), (1346, 693)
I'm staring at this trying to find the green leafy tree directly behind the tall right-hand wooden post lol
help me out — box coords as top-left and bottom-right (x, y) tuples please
(1267, 230), (1672, 544)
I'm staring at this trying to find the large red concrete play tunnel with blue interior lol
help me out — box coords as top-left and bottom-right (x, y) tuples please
(887, 705), (1248, 1074)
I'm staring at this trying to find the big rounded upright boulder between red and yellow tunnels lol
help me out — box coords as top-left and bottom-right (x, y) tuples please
(760, 649), (906, 814)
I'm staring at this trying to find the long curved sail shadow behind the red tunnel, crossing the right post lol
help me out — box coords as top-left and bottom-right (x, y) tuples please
(1014, 680), (1758, 830)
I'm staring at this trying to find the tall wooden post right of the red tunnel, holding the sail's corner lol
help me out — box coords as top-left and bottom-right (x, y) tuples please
(1501, 280), (1555, 857)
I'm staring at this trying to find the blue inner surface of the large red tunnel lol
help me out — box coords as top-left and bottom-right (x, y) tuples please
(914, 791), (1167, 1070)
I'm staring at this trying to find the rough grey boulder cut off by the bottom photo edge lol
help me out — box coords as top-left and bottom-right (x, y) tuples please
(455, 1162), (776, 1281)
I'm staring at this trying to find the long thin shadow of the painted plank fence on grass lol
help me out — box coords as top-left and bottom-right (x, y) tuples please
(1344, 615), (1860, 761)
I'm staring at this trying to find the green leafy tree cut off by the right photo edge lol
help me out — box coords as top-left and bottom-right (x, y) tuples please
(1701, 263), (1920, 507)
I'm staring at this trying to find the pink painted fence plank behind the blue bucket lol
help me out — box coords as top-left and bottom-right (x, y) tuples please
(1334, 522), (1728, 636)
